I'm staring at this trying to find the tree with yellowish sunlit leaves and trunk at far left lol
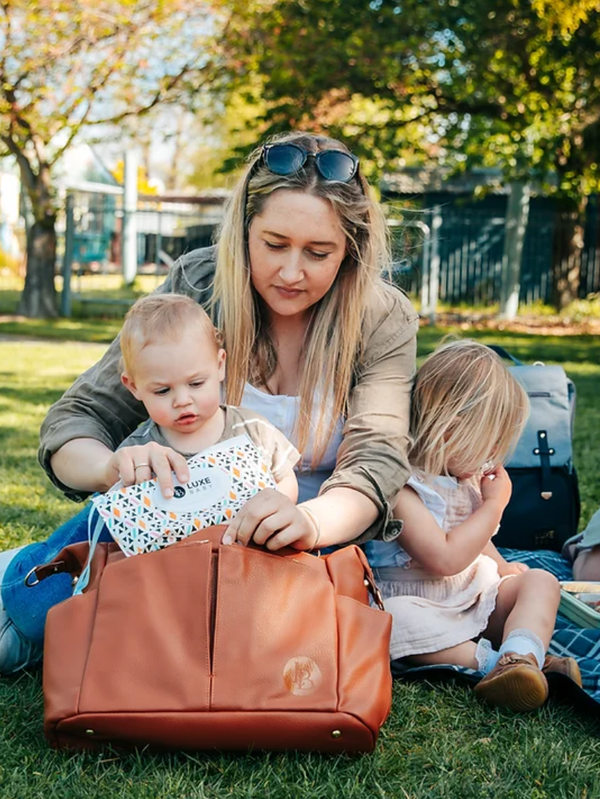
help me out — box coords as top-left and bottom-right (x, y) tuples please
(0, 0), (219, 316)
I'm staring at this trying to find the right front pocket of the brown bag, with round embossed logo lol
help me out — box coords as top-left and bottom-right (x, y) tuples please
(212, 546), (338, 711)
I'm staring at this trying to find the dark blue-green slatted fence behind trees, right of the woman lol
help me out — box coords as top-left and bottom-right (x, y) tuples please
(392, 197), (600, 306)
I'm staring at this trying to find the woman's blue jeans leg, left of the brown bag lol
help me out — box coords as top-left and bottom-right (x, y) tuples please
(1, 504), (112, 644)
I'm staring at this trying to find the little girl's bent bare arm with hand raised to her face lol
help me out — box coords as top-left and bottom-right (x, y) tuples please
(396, 466), (511, 577)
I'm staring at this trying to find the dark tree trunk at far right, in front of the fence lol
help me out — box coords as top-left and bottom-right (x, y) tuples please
(552, 197), (587, 311)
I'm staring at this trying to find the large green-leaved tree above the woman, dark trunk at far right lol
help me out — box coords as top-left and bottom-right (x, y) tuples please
(221, 0), (600, 306)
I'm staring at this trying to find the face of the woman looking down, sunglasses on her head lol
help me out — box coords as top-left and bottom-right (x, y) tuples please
(248, 189), (346, 318)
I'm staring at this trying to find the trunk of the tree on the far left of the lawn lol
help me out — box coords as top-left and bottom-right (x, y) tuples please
(18, 171), (58, 319)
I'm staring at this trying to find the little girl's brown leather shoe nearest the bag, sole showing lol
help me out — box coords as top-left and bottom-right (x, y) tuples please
(475, 652), (548, 711)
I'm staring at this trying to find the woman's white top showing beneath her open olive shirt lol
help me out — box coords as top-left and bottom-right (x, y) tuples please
(241, 383), (344, 502)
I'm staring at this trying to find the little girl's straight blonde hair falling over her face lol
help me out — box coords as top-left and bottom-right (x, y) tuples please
(409, 339), (529, 476)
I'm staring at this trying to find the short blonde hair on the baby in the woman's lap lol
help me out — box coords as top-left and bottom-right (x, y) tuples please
(121, 294), (221, 374)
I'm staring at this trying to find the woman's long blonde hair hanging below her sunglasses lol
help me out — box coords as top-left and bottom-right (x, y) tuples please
(212, 133), (391, 466)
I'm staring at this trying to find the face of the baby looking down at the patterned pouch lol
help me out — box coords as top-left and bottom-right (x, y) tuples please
(122, 327), (225, 433)
